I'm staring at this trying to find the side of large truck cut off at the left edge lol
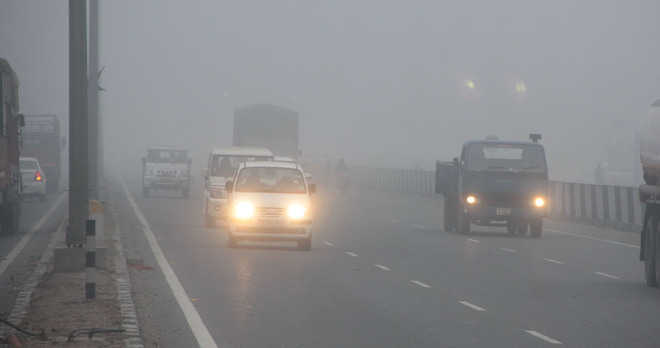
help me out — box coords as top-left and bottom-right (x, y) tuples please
(0, 58), (25, 234)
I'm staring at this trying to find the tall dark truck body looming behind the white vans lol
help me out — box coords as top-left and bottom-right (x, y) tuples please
(233, 104), (299, 159)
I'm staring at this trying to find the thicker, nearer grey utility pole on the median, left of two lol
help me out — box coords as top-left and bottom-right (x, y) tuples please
(66, 0), (89, 246)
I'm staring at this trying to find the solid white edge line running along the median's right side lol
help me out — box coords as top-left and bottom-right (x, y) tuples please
(120, 179), (218, 348)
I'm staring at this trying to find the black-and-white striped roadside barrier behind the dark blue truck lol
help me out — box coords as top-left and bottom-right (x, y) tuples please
(351, 167), (644, 232)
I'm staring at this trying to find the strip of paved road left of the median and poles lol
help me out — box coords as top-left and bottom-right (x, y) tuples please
(0, 193), (67, 318)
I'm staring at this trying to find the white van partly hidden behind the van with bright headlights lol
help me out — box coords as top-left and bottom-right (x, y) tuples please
(202, 147), (273, 227)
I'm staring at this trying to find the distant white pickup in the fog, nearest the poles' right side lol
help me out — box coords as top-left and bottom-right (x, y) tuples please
(142, 147), (192, 198)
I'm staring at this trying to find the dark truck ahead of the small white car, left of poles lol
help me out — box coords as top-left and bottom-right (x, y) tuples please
(21, 115), (66, 193)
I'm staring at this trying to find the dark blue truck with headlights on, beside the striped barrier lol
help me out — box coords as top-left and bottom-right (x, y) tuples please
(436, 134), (548, 238)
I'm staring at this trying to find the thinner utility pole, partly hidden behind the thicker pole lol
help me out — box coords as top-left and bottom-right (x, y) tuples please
(87, 0), (100, 199)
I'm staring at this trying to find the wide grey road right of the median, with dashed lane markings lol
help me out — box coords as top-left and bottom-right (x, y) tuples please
(112, 167), (660, 347)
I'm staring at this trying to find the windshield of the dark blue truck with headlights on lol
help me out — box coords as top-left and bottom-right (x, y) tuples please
(466, 144), (546, 173)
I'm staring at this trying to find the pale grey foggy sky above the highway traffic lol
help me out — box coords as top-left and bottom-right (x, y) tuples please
(0, 0), (660, 181)
